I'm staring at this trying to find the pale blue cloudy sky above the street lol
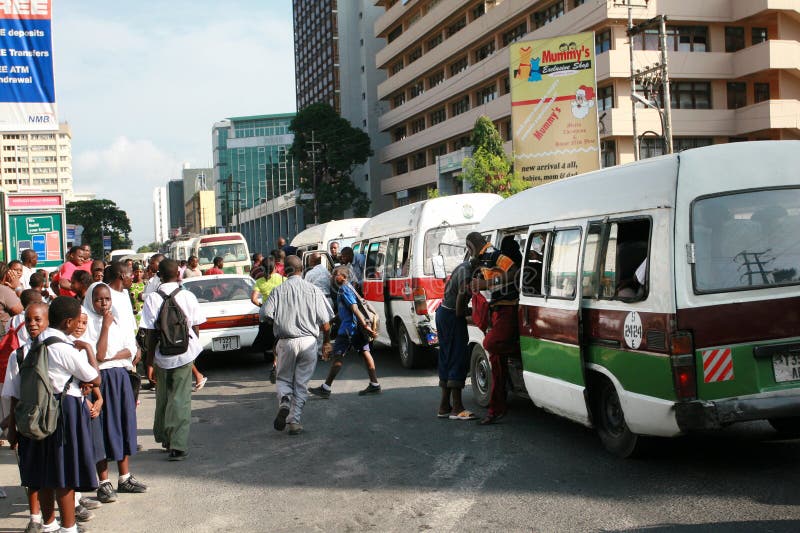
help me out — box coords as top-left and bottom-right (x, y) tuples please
(52, 0), (295, 248)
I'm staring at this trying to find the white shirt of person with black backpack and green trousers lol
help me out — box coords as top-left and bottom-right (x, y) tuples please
(141, 281), (206, 370)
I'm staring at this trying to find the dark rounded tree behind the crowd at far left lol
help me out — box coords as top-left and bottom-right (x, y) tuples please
(67, 200), (132, 254)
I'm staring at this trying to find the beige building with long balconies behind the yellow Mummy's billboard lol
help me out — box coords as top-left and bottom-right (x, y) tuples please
(374, 0), (800, 204)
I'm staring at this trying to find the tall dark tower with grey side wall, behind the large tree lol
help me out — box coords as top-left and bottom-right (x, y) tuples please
(293, 0), (391, 215)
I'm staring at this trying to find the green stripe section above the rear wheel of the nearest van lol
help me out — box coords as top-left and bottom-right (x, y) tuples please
(586, 346), (676, 401)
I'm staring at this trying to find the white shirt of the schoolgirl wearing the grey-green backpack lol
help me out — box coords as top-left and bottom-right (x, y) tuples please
(3, 328), (98, 398)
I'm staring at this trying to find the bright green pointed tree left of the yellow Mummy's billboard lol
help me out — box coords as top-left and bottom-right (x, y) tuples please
(459, 116), (530, 198)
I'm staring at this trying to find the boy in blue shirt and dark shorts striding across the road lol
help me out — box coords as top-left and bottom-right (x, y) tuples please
(309, 268), (381, 398)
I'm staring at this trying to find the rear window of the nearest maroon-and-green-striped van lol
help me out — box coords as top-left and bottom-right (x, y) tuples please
(692, 188), (800, 293)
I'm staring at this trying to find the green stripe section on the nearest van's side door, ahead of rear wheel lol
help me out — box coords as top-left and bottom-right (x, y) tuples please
(519, 337), (585, 385)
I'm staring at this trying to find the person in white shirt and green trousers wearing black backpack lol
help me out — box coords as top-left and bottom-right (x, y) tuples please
(140, 259), (206, 461)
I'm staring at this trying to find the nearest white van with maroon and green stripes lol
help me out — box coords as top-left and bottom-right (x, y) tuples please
(470, 141), (800, 456)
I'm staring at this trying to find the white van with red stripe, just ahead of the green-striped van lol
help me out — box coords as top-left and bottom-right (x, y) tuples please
(357, 193), (502, 368)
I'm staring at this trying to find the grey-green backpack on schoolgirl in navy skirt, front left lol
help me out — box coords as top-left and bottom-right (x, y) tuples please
(14, 337), (72, 440)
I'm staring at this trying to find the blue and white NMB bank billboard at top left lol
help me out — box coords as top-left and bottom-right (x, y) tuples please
(0, 0), (58, 131)
